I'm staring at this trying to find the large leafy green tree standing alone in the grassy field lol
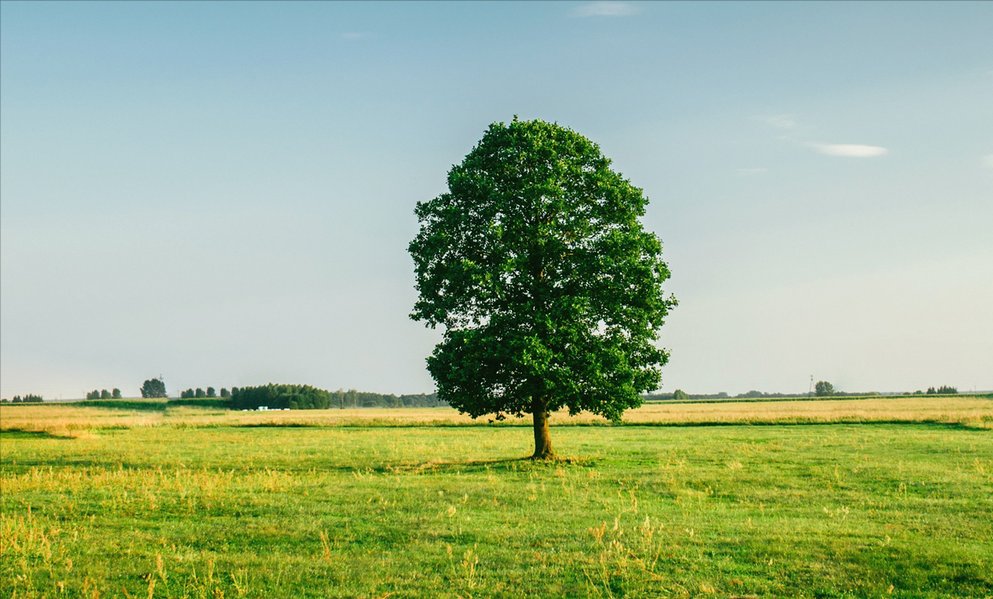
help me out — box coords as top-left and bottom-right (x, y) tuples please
(409, 117), (676, 458)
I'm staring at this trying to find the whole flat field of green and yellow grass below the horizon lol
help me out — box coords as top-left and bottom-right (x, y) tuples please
(0, 398), (993, 597)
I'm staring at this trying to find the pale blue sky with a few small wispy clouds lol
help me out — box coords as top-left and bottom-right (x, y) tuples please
(0, 2), (993, 399)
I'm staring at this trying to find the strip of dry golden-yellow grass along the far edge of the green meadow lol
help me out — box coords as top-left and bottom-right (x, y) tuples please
(0, 397), (993, 437)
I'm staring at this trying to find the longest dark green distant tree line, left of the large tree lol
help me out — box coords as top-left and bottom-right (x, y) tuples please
(231, 383), (447, 410)
